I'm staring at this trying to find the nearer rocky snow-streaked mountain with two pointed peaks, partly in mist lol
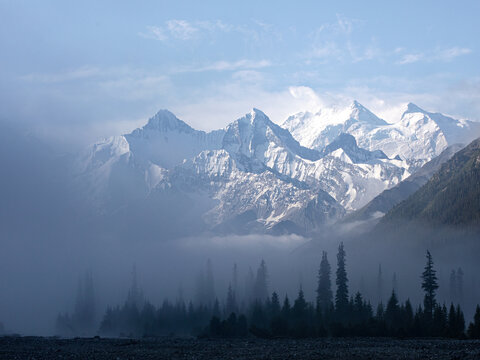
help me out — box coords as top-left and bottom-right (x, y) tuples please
(77, 109), (409, 232)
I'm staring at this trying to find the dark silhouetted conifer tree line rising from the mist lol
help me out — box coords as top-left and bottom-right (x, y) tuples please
(57, 243), (480, 339)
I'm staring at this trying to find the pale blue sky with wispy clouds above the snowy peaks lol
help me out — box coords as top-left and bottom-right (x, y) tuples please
(0, 0), (480, 145)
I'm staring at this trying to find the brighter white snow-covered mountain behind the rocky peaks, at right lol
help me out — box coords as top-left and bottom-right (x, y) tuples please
(283, 101), (478, 171)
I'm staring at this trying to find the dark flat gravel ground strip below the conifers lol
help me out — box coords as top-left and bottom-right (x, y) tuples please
(0, 337), (480, 360)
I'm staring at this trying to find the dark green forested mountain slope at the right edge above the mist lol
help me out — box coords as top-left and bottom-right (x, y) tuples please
(381, 139), (480, 225)
